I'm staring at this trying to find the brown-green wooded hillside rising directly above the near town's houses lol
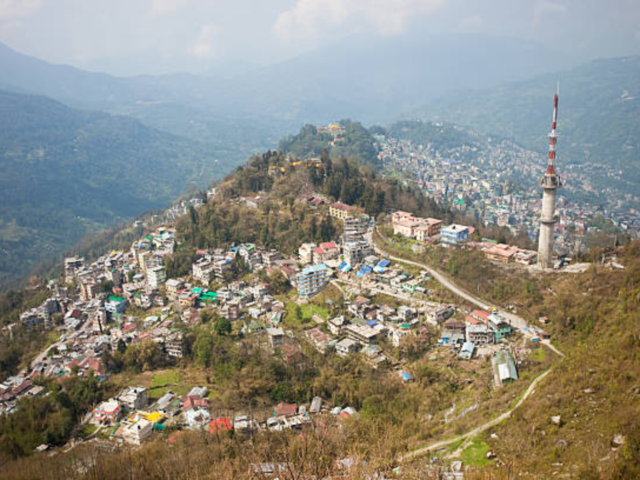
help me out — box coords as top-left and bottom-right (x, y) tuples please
(169, 148), (442, 270)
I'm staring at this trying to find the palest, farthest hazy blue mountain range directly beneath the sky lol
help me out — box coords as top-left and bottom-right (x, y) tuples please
(0, 34), (561, 127)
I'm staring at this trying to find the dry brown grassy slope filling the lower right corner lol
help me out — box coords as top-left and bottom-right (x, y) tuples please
(482, 242), (640, 479)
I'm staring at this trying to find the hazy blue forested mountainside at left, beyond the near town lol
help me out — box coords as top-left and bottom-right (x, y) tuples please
(0, 92), (227, 285)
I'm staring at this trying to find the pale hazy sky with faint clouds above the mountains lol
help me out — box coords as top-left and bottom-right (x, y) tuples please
(0, 0), (640, 74)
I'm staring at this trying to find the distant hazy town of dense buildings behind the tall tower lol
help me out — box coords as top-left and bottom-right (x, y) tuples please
(377, 136), (640, 253)
